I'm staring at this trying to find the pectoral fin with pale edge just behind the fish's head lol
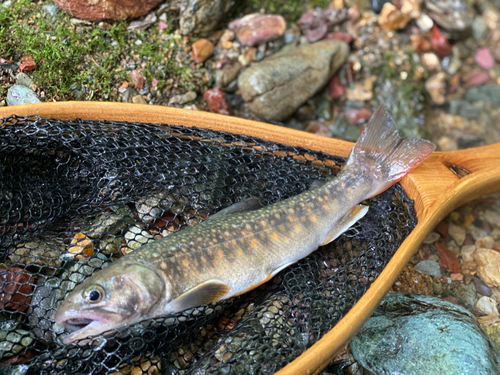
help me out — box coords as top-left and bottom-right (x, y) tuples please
(171, 280), (231, 311)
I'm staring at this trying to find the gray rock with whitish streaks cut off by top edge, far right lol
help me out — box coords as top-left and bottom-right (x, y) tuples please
(424, 0), (474, 32)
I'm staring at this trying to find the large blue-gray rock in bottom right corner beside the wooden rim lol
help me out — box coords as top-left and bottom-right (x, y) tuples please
(351, 293), (500, 375)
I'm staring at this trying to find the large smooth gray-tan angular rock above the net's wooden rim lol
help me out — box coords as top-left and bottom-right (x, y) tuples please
(238, 40), (349, 121)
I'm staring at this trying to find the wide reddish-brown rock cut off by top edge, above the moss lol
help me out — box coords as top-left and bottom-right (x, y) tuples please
(54, 0), (163, 21)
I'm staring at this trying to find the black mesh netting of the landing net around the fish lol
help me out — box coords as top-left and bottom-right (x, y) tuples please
(0, 116), (416, 374)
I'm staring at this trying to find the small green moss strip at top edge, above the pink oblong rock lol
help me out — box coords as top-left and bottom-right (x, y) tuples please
(234, 0), (331, 24)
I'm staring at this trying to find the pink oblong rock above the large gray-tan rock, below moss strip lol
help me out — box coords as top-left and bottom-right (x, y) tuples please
(228, 13), (286, 46)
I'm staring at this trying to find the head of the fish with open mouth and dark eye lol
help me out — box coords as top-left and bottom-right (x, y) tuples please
(55, 261), (166, 344)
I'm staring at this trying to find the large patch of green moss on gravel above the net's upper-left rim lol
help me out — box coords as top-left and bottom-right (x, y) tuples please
(0, 0), (203, 100)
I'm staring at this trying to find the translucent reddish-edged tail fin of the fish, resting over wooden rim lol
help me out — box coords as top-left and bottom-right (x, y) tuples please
(345, 104), (436, 196)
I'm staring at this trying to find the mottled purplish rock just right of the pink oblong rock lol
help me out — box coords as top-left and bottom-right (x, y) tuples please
(297, 8), (348, 43)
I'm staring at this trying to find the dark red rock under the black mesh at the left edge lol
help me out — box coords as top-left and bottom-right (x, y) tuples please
(0, 267), (33, 311)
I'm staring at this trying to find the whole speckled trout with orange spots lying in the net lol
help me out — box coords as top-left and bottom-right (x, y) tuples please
(55, 105), (435, 344)
